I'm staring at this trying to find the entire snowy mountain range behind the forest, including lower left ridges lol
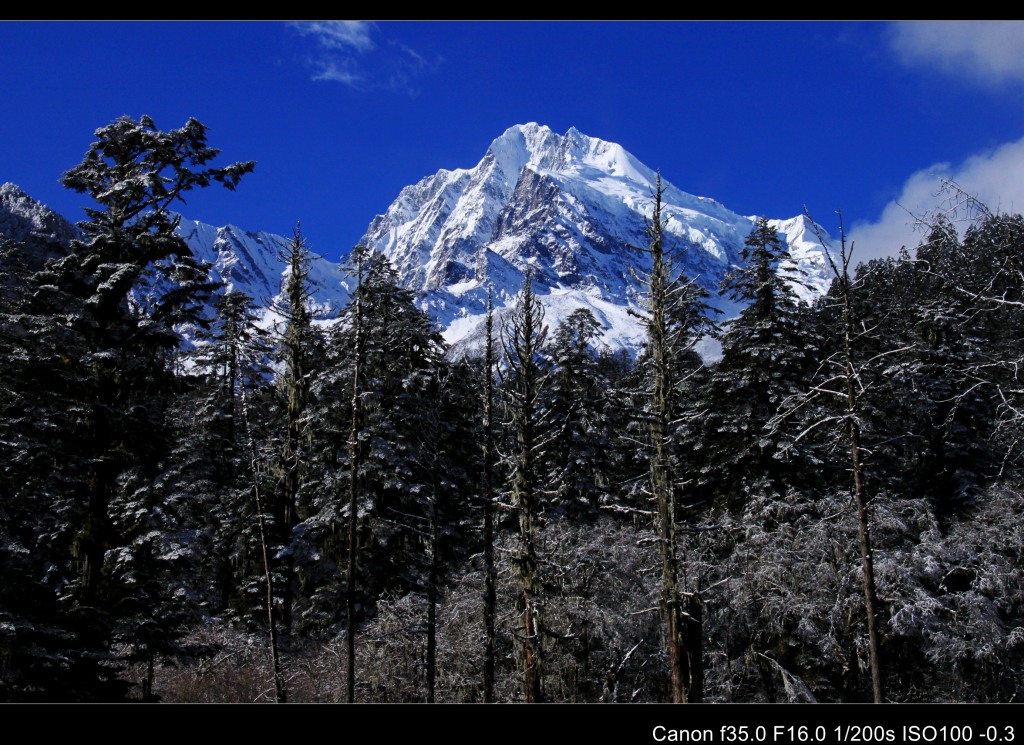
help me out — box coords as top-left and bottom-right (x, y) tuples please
(0, 123), (830, 358)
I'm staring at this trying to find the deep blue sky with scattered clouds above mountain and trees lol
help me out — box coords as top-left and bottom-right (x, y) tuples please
(6, 21), (1024, 258)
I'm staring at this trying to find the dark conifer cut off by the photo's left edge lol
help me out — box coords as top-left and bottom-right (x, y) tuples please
(0, 238), (117, 701)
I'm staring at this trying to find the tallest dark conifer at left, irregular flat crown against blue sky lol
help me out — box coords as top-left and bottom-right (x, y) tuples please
(28, 117), (253, 699)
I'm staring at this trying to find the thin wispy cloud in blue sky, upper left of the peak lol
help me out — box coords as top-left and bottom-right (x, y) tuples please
(291, 20), (434, 94)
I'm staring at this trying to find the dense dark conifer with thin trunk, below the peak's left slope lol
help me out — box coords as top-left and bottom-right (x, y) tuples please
(304, 247), (445, 699)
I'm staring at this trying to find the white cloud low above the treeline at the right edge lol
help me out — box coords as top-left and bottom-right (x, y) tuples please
(850, 138), (1024, 262)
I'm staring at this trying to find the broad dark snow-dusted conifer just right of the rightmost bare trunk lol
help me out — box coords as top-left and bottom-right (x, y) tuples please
(843, 220), (1001, 514)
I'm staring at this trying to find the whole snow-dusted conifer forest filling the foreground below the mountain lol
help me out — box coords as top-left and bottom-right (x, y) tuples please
(0, 117), (1024, 702)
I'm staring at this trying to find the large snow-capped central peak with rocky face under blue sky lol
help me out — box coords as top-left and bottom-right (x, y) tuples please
(361, 124), (829, 356)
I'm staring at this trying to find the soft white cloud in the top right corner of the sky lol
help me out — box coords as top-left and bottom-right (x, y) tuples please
(890, 20), (1024, 86)
